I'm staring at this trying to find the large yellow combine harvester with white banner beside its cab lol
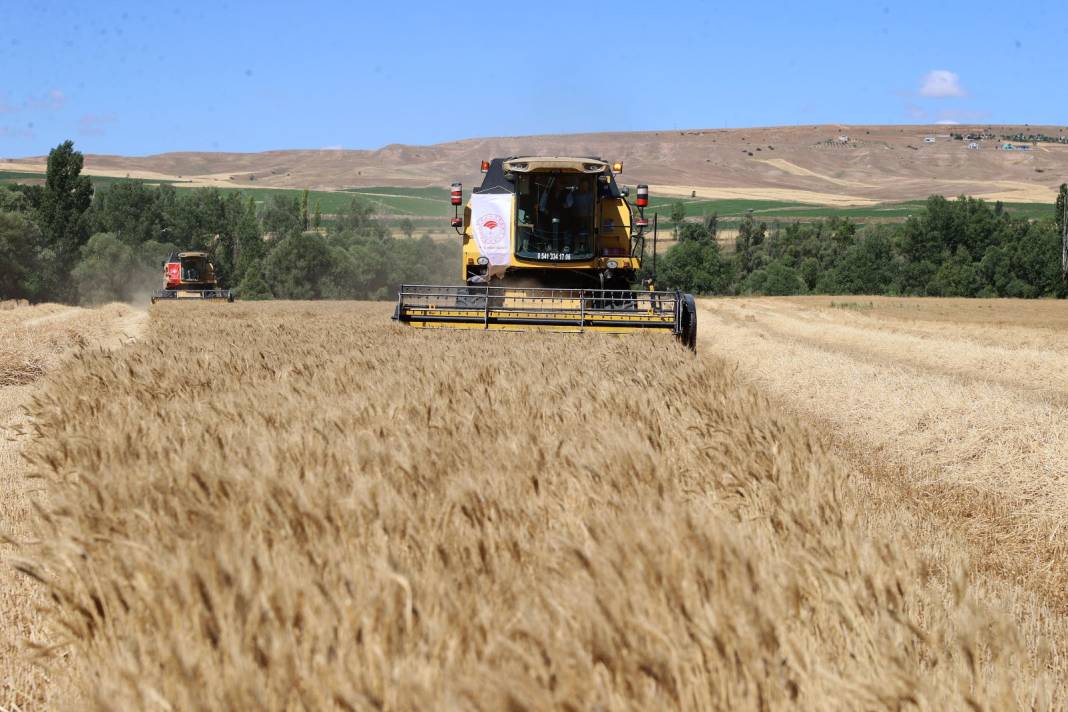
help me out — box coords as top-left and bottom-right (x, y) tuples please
(393, 156), (697, 349)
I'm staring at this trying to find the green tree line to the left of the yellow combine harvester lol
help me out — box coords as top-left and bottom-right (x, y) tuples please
(0, 141), (459, 303)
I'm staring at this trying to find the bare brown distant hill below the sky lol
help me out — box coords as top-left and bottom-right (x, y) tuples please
(0, 125), (1068, 205)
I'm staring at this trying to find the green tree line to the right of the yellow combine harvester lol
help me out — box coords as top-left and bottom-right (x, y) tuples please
(646, 186), (1068, 298)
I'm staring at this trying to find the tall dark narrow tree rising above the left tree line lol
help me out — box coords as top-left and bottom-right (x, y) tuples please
(37, 141), (93, 299)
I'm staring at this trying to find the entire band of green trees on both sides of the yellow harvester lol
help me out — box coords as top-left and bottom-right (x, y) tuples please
(0, 141), (1068, 303)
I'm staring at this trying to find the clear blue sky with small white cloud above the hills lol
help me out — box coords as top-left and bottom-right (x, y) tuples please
(0, 0), (1068, 157)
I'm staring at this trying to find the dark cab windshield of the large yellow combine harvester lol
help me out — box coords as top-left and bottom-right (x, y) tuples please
(516, 173), (597, 262)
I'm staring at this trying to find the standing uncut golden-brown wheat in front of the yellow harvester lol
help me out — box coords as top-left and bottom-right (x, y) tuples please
(12, 303), (1066, 710)
